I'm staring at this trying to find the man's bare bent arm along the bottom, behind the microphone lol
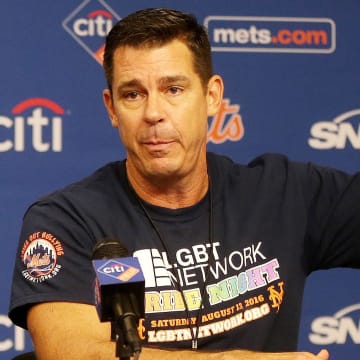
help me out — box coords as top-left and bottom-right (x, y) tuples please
(27, 302), (329, 360)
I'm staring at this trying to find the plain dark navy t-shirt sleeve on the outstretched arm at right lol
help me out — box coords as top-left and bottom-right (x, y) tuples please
(306, 165), (360, 271)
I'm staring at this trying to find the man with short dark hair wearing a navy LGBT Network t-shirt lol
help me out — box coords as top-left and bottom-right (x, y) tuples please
(9, 9), (360, 360)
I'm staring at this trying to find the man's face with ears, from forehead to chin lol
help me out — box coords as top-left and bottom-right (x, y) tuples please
(104, 40), (222, 183)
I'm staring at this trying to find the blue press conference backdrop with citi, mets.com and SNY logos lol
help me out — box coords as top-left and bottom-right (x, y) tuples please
(0, 0), (360, 360)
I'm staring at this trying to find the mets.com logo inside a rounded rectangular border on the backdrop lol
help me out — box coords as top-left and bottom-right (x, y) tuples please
(204, 16), (336, 54)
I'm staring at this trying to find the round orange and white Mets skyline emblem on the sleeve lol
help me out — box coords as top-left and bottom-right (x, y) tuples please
(21, 231), (64, 283)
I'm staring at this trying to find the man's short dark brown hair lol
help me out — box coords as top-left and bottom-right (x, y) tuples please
(103, 8), (213, 91)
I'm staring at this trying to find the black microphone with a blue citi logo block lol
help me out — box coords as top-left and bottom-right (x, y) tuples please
(91, 239), (145, 359)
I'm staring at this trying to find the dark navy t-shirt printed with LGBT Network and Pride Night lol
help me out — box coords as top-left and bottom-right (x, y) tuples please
(9, 153), (360, 351)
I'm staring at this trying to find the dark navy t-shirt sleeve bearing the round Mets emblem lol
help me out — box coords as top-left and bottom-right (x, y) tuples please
(9, 201), (95, 328)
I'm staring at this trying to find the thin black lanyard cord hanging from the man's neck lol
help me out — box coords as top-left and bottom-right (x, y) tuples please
(128, 177), (214, 350)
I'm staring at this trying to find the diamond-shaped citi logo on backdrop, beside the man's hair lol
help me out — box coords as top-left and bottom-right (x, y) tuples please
(62, 0), (120, 64)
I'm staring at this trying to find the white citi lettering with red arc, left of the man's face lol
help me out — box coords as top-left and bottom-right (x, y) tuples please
(0, 98), (64, 152)
